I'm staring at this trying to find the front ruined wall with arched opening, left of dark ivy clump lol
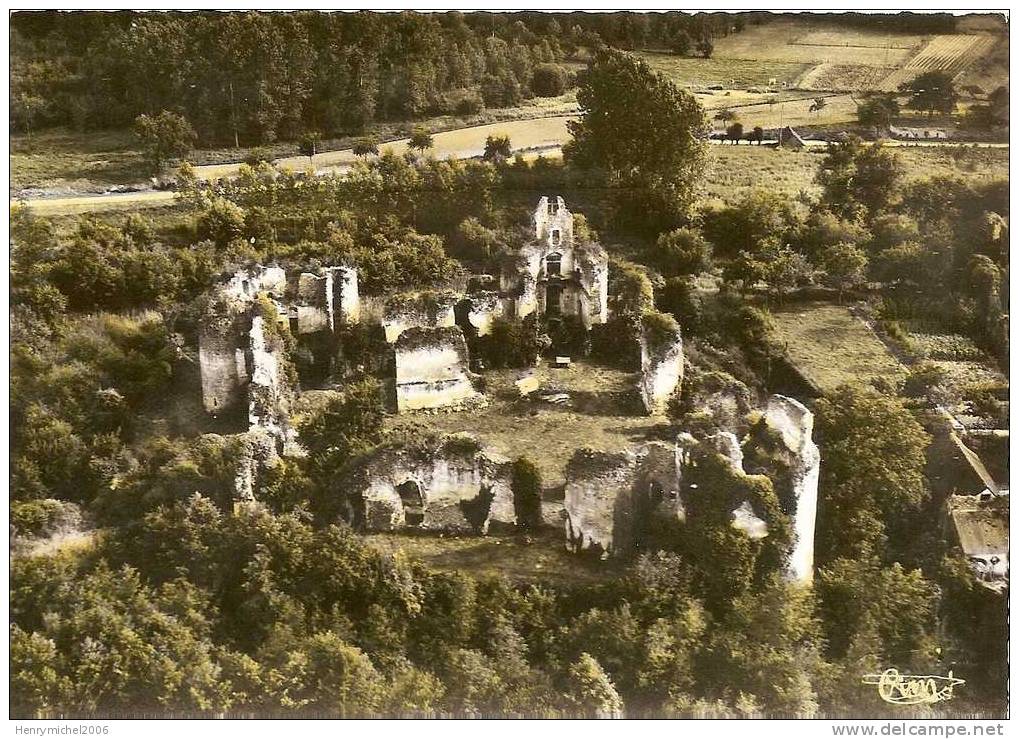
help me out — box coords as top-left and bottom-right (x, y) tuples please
(348, 434), (517, 534)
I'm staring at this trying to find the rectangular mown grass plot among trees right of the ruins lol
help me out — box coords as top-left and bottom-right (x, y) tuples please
(771, 303), (906, 392)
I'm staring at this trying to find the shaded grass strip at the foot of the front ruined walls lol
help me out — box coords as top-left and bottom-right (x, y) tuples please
(365, 530), (622, 585)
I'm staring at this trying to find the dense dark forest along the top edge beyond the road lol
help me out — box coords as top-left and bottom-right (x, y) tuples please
(10, 11), (955, 146)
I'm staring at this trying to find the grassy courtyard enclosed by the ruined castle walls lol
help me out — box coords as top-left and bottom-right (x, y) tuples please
(387, 362), (662, 487)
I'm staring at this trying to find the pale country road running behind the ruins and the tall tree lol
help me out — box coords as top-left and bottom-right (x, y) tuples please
(10, 115), (1009, 215)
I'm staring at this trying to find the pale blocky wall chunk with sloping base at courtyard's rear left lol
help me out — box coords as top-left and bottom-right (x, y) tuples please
(394, 326), (482, 411)
